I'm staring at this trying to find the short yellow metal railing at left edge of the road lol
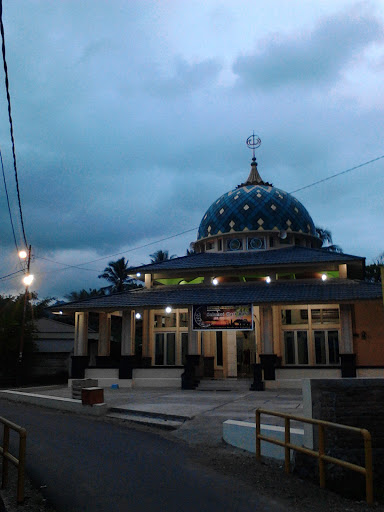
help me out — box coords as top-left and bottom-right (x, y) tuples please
(0, 416), (27, 503)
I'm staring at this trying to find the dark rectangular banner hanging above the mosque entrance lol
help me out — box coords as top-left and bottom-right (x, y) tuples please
(192, 304), (253, 331)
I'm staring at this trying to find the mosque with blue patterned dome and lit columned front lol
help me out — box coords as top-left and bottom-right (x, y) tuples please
(56, 135), (384, 389)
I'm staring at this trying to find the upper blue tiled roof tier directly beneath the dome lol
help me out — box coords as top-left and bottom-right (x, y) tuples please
(130, 246), (365, 274)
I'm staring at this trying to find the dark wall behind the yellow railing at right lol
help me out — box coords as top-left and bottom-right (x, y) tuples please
(296, 379), (384, 498)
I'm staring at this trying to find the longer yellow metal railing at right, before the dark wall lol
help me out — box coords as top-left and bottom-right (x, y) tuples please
(256, 409), (373, 505)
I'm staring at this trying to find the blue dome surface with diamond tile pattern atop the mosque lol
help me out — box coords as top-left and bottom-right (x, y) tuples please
(197, 185), (316, 240)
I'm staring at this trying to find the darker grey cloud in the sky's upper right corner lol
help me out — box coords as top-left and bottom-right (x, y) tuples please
(233, 7), (383, 90)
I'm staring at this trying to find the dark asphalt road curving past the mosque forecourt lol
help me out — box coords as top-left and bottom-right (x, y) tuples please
(0, 401), (285, 512)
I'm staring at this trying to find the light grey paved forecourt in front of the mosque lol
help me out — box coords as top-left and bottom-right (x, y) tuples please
(13, 381), (303, 445)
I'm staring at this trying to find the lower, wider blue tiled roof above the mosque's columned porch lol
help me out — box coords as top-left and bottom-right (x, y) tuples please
(52, 279), (382, 311)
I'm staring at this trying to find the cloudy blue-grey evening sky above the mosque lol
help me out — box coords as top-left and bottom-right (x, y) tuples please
(0, 0), (384, 298)
